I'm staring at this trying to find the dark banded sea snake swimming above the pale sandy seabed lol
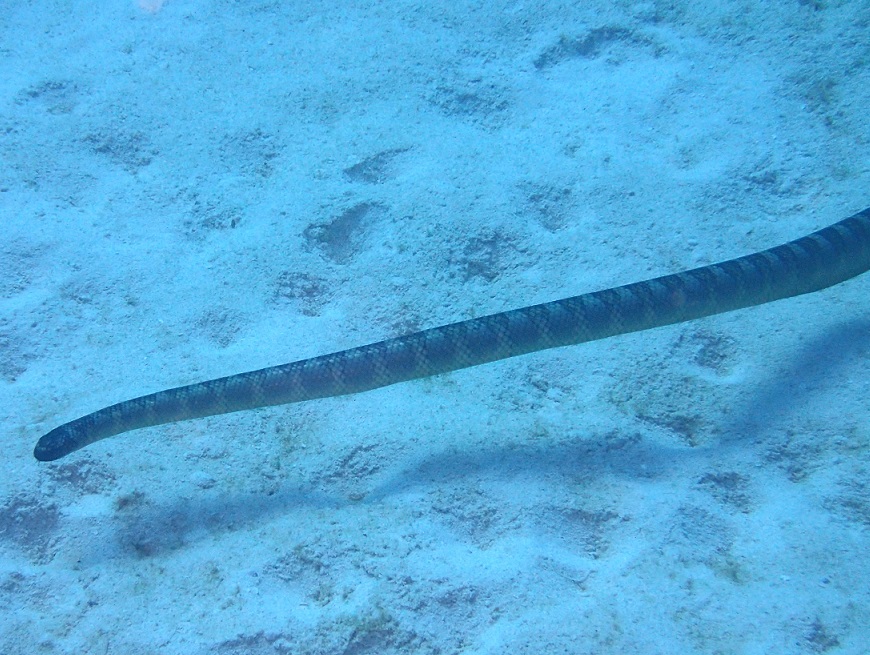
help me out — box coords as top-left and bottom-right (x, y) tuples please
(33, 208), (870, 461)
